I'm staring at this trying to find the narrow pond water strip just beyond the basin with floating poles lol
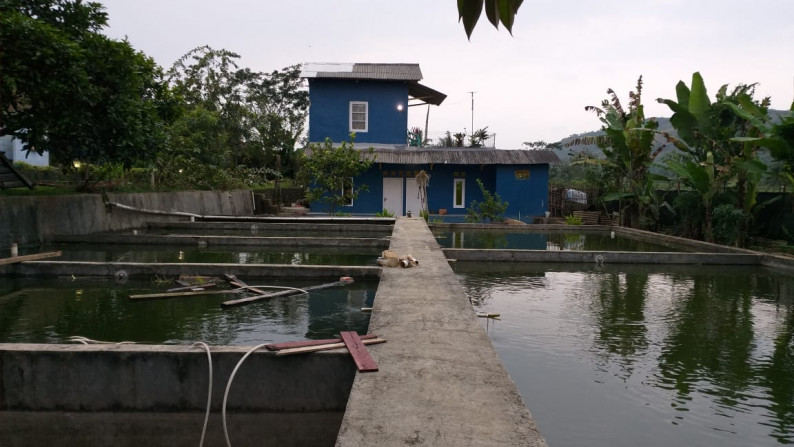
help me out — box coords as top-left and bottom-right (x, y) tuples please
(40, 244), (381, 265)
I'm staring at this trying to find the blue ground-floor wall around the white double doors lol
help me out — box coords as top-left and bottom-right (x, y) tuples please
(311, 162), (549, 220)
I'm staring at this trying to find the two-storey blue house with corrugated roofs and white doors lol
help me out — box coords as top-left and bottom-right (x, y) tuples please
(303, 64), (559, 218)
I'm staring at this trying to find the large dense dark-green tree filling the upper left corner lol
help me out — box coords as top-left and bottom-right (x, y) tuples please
(0, 0), (174, 166)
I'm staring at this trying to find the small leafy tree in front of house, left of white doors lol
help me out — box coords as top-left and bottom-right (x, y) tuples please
(298, 134), (374, 214)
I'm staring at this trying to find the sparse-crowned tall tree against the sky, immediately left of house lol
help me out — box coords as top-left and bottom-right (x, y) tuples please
(168, 46), (309, 172)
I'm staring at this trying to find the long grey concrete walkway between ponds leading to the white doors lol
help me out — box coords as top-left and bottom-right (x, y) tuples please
(336, 219), (546, 447)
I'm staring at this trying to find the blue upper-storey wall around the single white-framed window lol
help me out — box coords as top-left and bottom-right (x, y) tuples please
(309, 78), (408, 144)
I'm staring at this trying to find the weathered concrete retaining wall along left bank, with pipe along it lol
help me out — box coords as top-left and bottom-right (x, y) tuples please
(0, 190), (254, 253)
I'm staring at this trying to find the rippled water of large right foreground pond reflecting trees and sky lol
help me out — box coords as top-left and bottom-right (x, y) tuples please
(457, 264), (794, 447)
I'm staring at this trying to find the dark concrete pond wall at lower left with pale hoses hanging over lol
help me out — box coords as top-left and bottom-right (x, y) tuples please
(0, 344), (356, 447)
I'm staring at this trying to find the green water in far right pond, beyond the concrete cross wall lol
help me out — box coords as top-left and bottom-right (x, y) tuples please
(433, 230), (682, 252)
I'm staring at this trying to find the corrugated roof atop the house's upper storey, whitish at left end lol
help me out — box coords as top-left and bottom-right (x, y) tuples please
(302, 63), (422, 81)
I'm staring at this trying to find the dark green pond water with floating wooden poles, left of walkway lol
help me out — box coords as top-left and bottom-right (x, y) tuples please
(0, 278), (377, 346)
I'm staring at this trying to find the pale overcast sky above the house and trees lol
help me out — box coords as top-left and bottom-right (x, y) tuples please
(97, 0), (794, 149)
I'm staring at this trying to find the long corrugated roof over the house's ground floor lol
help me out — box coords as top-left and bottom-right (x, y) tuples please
(356, 149), (560, 165)
